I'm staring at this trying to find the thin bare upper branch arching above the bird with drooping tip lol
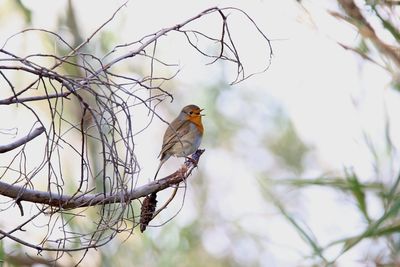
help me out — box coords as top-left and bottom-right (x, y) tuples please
(0, 7), (273, 105)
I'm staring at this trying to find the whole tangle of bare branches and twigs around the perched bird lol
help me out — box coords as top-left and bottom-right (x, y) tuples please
(0, 5), (272, 255)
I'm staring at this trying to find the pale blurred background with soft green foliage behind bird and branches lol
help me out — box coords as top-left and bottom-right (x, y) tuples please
(0, 0), (400, 266)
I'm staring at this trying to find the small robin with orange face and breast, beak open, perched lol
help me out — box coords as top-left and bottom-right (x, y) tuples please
(154, 104), (204, 180)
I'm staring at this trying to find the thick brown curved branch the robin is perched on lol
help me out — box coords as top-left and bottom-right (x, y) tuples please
(0, 150), (204, 209)
